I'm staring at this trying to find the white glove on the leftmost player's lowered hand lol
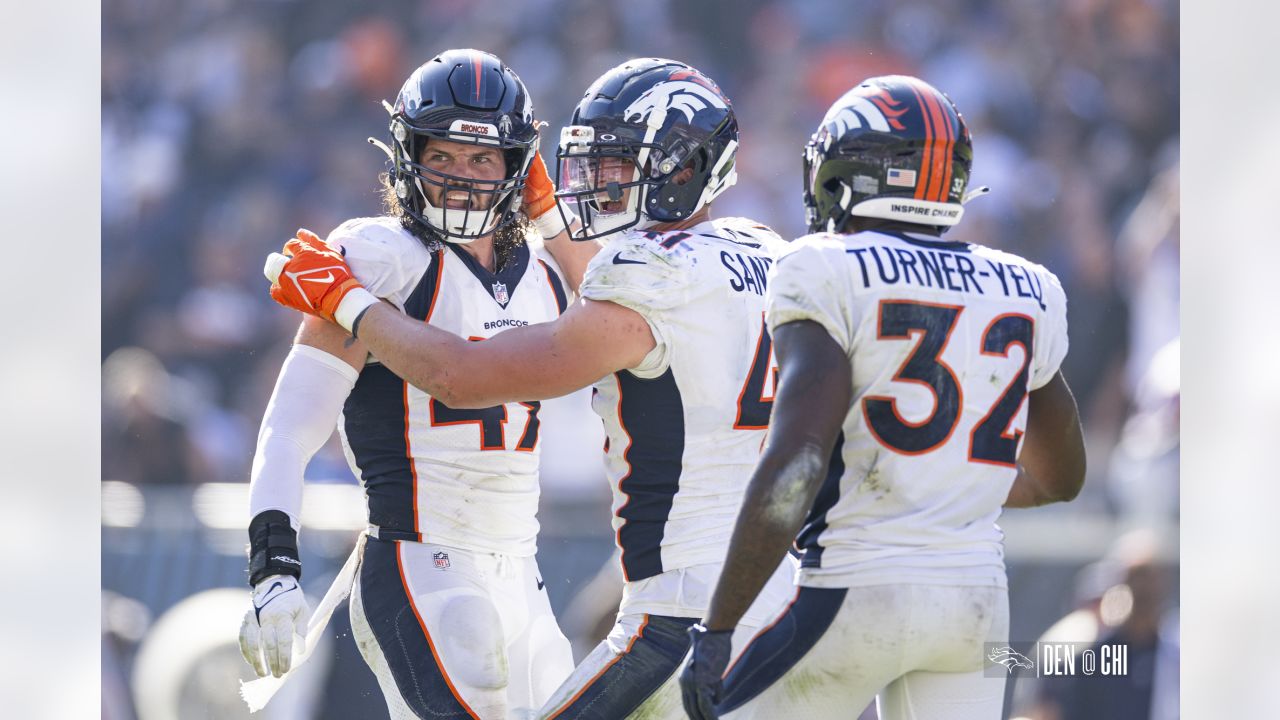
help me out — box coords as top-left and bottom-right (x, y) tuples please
(241, 575), (311, 678)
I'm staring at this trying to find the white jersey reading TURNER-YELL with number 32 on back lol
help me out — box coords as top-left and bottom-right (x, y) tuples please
(768, 232), (1066, 587)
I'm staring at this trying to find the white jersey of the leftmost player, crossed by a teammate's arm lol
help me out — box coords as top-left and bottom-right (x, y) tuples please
(329, 217), (567, 556)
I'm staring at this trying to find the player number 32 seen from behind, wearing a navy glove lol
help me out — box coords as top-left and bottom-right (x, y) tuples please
(681, 76), (1084, 720)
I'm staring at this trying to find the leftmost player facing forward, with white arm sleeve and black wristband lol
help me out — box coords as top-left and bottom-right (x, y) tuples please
(241, 50), (594, 717)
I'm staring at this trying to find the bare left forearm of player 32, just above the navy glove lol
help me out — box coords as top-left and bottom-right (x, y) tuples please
(704, 443), (829, 630)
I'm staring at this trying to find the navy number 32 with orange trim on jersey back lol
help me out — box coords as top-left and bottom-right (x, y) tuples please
(863, 300), (1036, 466)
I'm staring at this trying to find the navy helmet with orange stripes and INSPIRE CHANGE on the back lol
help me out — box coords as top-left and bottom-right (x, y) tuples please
(804, 76), (973, 232)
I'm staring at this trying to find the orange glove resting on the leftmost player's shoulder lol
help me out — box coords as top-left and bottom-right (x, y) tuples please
(262, 229), (378, 331)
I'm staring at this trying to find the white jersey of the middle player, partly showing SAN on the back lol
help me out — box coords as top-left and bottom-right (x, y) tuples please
(581, 218), (782, 582)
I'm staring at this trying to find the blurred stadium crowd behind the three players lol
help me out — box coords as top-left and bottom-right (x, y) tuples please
(101, 0), (1180, 720)
